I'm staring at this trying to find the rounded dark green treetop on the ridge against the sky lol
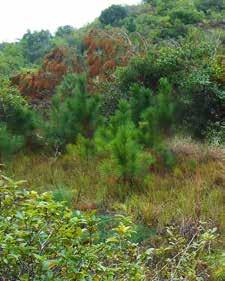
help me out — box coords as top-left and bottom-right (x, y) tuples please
(99, 5), (127, 26)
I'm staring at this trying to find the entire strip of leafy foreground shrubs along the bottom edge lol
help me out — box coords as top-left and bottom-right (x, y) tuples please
(0, 176), (224, 281)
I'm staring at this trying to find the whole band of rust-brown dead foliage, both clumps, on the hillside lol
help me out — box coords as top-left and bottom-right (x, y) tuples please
(11, 29), (148, 104)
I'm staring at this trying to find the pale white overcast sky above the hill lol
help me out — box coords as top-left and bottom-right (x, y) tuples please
(0, 0), (141, 42)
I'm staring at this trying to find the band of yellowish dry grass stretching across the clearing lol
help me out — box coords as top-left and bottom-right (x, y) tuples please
(6, 138), (225, 233)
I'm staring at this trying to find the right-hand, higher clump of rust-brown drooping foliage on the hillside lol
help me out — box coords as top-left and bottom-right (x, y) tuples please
(84, 29), (135, 91)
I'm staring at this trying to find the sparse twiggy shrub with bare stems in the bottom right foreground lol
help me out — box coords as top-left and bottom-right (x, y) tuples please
(148, 222), (218, 281)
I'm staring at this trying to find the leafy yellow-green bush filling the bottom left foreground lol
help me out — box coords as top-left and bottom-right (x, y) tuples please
(0, 176), (145, 281)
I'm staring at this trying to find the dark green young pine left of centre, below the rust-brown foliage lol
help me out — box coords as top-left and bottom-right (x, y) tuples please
(46, 74), (100, 149)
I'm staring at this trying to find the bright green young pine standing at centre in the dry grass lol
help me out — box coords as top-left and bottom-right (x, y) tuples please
(95, 100), (153, 186)
